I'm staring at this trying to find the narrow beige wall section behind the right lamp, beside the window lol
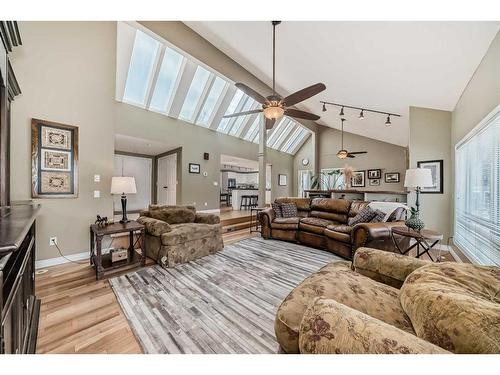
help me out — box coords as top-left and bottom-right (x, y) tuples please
(408, 107), (452, 241)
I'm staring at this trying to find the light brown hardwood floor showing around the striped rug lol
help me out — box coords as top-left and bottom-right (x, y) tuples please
(36, 229), (254, 354)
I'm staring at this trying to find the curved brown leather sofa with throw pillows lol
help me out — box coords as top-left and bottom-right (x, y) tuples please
(259, 198), (407, 260)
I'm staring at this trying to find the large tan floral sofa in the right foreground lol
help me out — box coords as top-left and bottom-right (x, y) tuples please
(275, 248), (500, 354)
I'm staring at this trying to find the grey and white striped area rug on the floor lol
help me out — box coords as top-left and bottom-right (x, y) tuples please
(109, 237), (341, 353)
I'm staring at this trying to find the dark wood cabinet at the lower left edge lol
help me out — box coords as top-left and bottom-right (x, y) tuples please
(0, 205), (40, 354)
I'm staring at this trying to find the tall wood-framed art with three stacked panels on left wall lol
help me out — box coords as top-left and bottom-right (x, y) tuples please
(31, 119), (78, 198)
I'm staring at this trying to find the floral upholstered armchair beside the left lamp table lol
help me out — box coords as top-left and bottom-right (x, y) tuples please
(137, 205), (224, 267)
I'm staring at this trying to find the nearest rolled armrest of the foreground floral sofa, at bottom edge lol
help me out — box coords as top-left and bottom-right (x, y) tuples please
(299, 298), (450, 354)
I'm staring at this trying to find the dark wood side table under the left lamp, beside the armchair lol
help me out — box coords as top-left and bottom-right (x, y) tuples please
(90, 221), (146, 280)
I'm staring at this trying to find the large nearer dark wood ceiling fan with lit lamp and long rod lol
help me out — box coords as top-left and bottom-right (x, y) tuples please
(223, 21), (326, 129)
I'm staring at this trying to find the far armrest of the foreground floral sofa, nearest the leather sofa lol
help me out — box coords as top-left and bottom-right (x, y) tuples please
(353, 247), (432, 288)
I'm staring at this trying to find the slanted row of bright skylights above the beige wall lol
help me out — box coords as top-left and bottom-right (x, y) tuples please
(117, 22), (310, 154)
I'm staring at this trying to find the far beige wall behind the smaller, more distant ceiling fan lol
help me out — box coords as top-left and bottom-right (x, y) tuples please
(318, 127), (406, 191)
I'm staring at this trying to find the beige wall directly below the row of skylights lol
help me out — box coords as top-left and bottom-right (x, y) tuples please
(116, 103), (293, 210)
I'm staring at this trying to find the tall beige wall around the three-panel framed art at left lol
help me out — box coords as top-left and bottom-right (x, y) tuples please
(11, 22), (116, 259)
